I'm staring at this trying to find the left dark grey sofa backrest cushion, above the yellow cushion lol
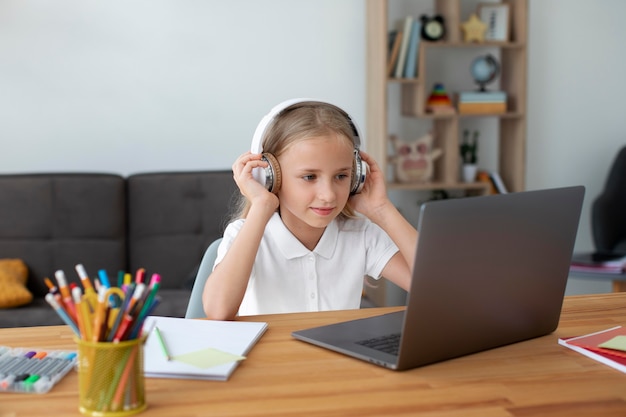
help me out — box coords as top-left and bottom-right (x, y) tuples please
(0, 173), (126, 297)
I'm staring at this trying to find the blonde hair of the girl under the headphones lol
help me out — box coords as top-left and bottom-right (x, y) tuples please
(231, 101), (357, 220)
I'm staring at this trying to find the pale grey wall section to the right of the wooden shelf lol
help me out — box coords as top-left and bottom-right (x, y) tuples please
(526, 0), (626, 293)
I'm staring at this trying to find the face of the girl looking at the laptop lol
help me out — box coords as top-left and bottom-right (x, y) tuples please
(277, 133), (353, 244)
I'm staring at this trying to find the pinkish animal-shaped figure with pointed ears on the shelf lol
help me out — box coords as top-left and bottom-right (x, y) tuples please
(391, 132), (442, 183)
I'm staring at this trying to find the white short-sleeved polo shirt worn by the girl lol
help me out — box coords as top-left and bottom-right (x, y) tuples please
(215, 213), (398, 315)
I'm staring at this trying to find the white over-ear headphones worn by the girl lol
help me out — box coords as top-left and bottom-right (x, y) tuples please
(250, 98), (367, 195)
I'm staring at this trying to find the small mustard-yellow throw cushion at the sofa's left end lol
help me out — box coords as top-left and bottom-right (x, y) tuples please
(0, 259), (33, 308)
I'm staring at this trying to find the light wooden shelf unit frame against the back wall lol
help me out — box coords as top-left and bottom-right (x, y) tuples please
(366, 0), (528, 193)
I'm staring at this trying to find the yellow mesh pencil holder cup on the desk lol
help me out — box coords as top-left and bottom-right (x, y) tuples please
(76, 336), (147, 417)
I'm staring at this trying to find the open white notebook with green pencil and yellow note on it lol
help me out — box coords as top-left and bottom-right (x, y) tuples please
(144, 316), (267, 381)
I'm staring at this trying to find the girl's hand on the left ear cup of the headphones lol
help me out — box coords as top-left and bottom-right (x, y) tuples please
(232, 151), (278, 212)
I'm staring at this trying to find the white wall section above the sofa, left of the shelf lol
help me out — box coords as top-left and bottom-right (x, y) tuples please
(0, 0), (365, 174)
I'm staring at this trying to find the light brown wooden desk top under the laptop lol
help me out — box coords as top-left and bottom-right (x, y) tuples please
(0, 293), (626, 417)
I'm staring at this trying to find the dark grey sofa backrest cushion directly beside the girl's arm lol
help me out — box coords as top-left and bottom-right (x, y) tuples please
(127, 170), (238, 289)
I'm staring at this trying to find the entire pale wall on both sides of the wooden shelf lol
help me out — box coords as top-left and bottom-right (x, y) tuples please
(0, 0), (626, 293)
